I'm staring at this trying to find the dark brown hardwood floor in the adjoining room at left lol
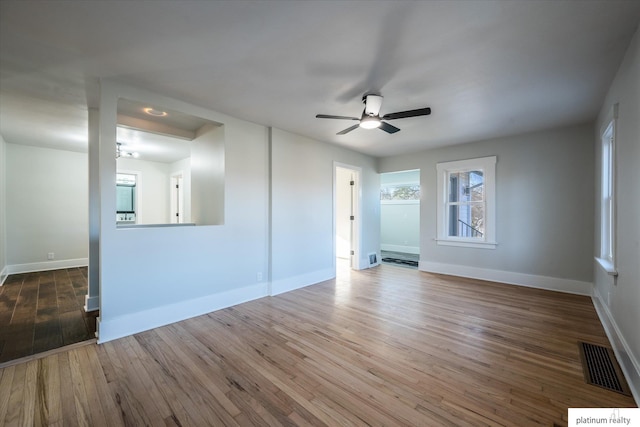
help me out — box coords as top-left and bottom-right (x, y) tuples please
(0, 268), (98, 363)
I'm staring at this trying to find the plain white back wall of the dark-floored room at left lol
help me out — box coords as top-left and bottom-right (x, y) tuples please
(5, 144), (89, 273)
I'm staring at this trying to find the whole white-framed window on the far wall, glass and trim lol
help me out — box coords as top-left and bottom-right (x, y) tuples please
(436, 156), (496, 249)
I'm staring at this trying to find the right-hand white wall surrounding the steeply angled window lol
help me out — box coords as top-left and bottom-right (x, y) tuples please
(592, 27), (640, 402)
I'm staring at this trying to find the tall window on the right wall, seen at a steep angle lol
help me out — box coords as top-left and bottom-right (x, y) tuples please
(596, 105), (617, 275)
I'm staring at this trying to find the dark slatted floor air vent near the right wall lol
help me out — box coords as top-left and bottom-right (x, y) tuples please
(578, 342), (631, 396)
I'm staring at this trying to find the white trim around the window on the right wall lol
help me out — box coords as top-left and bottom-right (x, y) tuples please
(595, 104), (618, 276)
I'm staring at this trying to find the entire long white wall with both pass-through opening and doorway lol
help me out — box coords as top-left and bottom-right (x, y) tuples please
(96, 81), (380, 342)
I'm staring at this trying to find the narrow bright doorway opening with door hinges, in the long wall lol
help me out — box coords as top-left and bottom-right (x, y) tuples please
(333, 163), (361, 271)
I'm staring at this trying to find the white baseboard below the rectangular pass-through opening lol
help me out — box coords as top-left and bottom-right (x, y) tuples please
(96, 283), (267, 344)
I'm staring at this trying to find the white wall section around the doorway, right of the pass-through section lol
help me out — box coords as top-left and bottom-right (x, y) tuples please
(271, 129), (380, 293)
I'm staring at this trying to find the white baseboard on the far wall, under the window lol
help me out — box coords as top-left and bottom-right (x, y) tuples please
(418, 261), (593, 296)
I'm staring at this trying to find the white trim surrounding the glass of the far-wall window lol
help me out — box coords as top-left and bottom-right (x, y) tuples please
(436, 156), (498, 249)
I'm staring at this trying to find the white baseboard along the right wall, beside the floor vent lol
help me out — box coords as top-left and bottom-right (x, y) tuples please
(591, 288), (640, 405)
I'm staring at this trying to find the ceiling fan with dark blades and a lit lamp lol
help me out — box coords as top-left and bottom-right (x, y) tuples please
(316, 94), (431, 135)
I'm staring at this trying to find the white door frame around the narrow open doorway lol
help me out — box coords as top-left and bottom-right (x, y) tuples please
(332, 161), (363, 271)
